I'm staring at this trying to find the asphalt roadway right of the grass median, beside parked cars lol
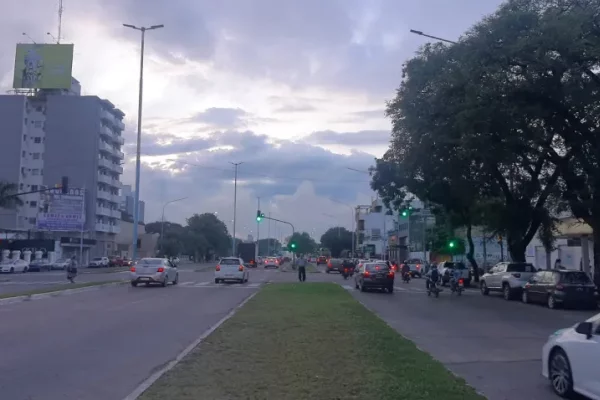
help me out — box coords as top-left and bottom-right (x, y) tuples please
(340, 274), (595, 400)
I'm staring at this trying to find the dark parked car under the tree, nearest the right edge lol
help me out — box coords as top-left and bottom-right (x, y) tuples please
(521, 269), (598, 309)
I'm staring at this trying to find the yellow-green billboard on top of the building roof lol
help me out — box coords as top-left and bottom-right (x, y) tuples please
(13, 43), (73, 89)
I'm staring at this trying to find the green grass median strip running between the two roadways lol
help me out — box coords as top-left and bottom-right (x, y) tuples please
(140, 283), (483, 400)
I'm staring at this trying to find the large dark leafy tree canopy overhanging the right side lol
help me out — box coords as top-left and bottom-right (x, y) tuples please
(373, 0), (600, 266)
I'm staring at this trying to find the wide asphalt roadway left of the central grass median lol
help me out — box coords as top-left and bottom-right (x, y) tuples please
(0, 264), (284, 400)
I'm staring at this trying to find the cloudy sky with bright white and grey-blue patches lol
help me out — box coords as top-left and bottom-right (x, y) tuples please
(0, 0), (500, 238)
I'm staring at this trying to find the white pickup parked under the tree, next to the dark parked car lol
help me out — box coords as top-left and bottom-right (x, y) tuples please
(479, 262), (537, 300)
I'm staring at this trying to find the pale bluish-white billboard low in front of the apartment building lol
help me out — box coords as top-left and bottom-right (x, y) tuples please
(37, 188), (85, 232)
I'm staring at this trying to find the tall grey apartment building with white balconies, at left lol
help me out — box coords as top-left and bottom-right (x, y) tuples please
(0, 86), (124, 260)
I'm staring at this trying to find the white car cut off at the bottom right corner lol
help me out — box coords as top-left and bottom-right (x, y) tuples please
(542, 314), (600, 400)
